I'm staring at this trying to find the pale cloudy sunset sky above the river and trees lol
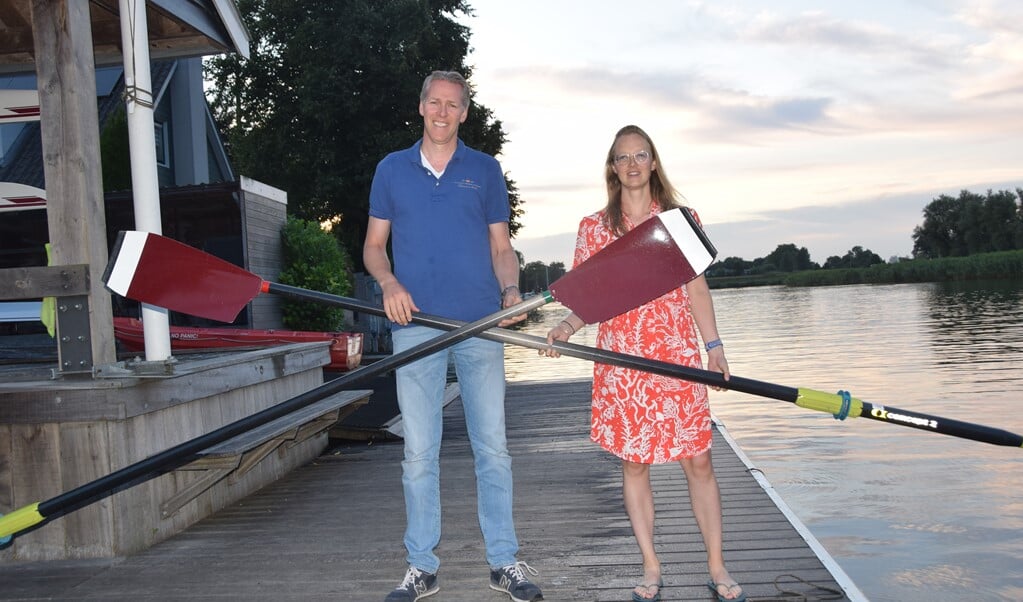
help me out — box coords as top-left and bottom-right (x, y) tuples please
(456, 0), (1023, 267)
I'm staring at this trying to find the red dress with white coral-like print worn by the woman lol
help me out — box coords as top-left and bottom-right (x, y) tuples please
(574, 204), (711, 464)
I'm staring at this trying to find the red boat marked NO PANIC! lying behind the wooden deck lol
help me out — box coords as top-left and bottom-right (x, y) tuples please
(114, 317), (362, 372)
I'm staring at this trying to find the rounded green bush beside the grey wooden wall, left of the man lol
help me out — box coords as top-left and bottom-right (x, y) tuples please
(278, 217), (352, 332)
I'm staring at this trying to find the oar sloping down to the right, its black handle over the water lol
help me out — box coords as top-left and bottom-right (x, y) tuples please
(96, 220), (1023, 447)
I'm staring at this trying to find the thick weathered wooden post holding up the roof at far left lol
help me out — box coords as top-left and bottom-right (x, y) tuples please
(32, 0), (117, 366)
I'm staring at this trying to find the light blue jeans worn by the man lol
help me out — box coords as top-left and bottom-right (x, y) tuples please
(392, 326), (519, 572)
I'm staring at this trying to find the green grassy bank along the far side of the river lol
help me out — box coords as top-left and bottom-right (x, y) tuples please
(707, 250), (1023, 289)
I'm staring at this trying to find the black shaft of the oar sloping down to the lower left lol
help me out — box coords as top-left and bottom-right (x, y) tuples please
(39, 295), (552, 519)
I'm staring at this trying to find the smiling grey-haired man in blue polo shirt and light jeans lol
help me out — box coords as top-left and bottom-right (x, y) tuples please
(363, 71), (543, 602)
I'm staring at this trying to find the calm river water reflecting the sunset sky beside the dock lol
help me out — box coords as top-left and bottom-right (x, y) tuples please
(506, 282), (1023, 602)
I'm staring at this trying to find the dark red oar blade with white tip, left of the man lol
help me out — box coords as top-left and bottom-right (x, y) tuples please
(103, 230), (263, 323)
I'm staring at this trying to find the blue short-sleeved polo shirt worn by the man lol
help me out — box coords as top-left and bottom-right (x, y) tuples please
(369, 139), (510, 327)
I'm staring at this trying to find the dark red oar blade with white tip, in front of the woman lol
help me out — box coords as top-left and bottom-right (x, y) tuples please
(550, 208), (717, 324)
